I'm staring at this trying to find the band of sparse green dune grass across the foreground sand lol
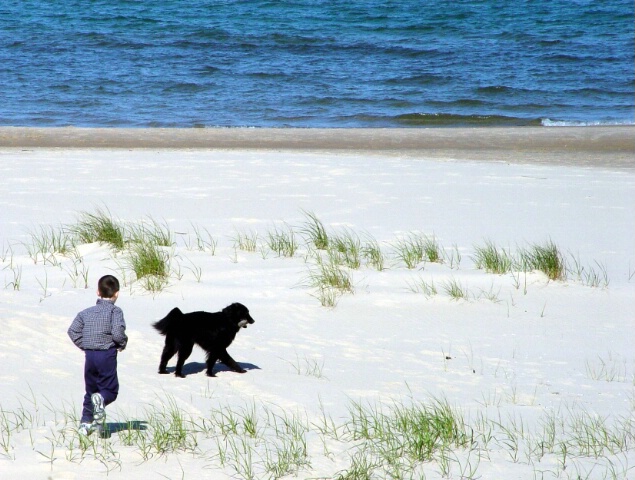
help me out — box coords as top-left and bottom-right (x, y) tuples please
(0, 392), (635, 480)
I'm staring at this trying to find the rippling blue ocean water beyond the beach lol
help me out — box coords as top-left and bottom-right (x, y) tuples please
(0, 0), (635, 127)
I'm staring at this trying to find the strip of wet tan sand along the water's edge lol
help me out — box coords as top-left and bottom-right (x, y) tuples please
(0, 126), (635, 169)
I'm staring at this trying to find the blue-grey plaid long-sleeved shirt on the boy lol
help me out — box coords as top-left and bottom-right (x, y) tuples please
(68, 298), (128, 350)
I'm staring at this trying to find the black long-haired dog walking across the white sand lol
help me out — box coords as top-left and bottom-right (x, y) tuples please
(152, 303), (254, 378)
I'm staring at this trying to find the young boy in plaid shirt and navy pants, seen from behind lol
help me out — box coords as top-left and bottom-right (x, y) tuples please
(68, 275), (128, 435)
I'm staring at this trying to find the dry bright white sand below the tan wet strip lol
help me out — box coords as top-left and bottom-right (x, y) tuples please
(0, 129), (635, 479)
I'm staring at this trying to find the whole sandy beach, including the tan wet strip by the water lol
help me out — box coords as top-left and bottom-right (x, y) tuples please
(0, 126), (635, 479)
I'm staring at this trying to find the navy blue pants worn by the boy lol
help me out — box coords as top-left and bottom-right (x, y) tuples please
(82, 348), (119, 423)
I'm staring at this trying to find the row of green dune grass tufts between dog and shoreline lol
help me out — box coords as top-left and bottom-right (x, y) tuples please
(2, 209), (610, 298)
